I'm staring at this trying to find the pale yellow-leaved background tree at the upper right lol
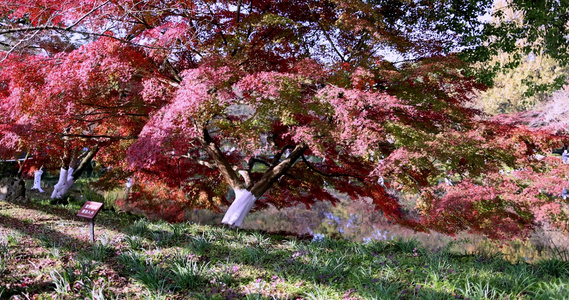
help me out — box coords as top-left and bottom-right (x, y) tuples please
(476, 1), (569, 115)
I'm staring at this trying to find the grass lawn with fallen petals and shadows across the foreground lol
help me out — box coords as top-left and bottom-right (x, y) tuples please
(0, 193), (569, 299)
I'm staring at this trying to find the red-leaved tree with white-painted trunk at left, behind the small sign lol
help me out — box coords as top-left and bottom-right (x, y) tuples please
(0, 39), (156, 198)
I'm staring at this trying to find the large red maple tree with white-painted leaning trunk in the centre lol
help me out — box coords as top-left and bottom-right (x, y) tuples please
(0, 0), (567, 238)
